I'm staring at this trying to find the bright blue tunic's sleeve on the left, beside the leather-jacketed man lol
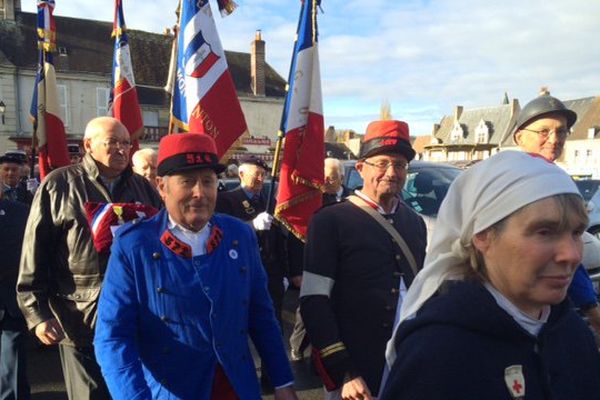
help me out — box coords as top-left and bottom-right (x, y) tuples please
(94, 240), (152, 400)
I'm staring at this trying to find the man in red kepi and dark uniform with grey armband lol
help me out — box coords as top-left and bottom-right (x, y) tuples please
(300, 121), (427, 400)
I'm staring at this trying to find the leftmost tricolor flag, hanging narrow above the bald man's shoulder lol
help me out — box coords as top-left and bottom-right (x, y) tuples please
(30, 0), (70, 179)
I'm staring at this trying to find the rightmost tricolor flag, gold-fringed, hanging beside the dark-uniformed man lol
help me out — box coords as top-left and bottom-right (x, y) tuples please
(275, 0), (325, 241)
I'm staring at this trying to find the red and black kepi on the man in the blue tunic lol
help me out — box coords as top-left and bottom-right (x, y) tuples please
(157, 133), (225, 176)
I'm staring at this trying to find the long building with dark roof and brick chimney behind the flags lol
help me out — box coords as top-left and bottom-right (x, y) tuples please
(0, 0), (286, 159)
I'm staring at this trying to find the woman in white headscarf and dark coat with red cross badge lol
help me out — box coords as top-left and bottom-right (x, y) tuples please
(380, 151), (600, 400)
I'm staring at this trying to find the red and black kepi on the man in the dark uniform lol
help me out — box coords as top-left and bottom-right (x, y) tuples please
(358, 120), (415, 161)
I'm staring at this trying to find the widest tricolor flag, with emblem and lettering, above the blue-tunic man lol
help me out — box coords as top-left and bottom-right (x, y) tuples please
(172, 0), (248, 157)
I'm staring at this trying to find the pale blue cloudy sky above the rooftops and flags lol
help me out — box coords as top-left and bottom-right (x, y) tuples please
(22, 0), (600, 135)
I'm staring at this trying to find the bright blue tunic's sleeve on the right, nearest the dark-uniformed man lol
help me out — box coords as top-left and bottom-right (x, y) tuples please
(248, 228), (294, 387)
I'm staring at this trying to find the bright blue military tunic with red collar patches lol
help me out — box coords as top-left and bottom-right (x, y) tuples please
(94, 210), (293, 400)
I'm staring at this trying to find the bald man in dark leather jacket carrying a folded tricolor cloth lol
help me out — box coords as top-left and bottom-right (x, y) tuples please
(17, 117), (161, 400)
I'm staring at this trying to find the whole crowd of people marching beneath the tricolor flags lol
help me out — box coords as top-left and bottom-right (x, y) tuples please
(0, 95), (600, 400)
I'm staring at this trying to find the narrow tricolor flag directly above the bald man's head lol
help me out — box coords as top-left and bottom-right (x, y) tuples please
(109, 0), (144, 155)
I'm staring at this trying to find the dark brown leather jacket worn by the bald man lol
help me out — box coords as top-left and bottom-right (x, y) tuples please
(17, 154), (161, 346)
